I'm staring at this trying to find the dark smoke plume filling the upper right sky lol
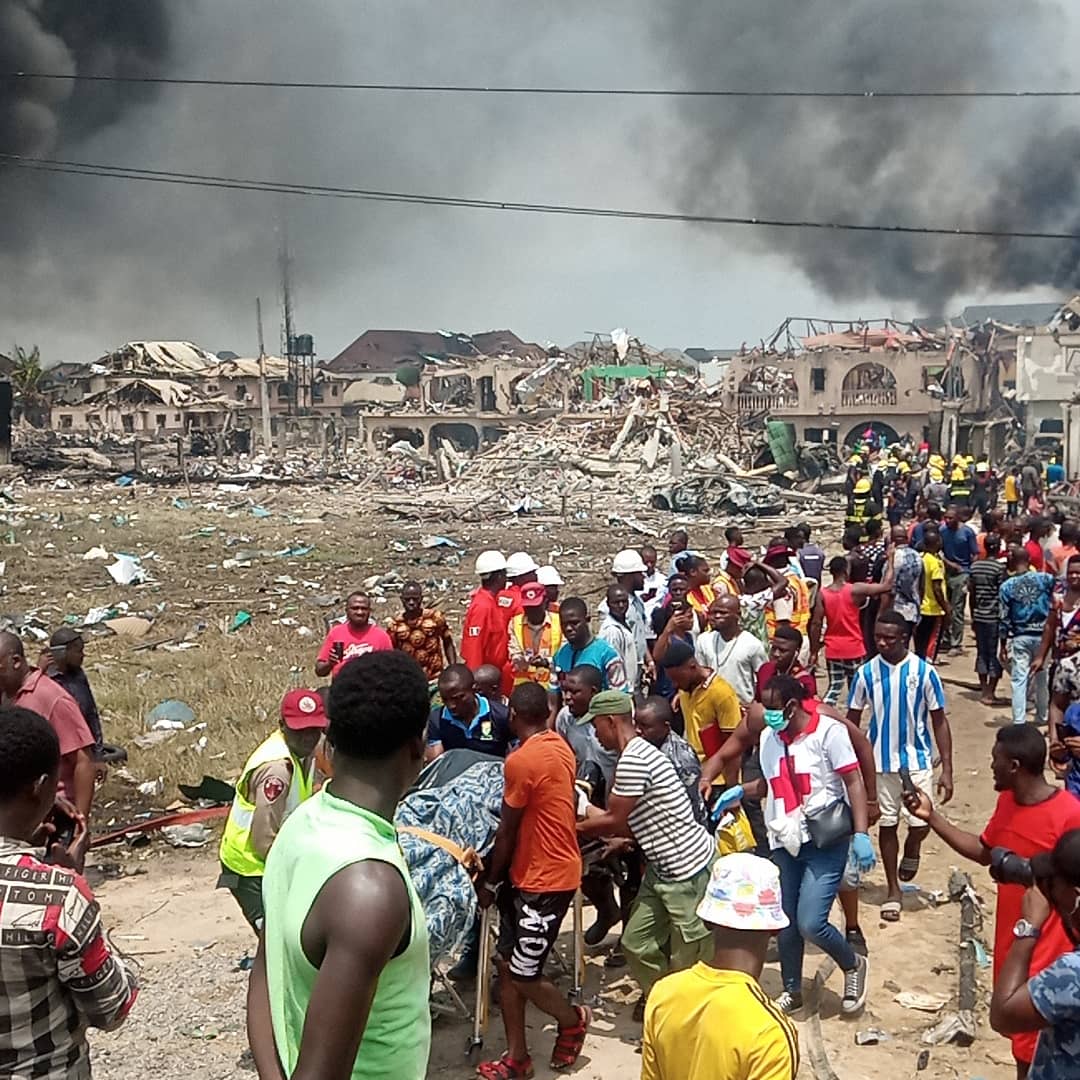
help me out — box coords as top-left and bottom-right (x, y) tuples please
(660, 0), (1080, 312)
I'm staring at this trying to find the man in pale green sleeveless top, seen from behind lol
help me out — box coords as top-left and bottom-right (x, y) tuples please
(247, 651), (431, 1080)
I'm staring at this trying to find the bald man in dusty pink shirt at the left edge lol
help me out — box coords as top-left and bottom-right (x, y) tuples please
(0, 631), (94, 818)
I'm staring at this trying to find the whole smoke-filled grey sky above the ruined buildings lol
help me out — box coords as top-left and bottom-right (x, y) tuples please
(0, 0), (1080, 362)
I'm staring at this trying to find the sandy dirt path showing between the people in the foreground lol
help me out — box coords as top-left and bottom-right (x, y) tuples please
(93, 658), (1014, 1080)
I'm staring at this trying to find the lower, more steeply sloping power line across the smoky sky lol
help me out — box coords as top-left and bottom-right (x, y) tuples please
(0, 153), (1080, 242)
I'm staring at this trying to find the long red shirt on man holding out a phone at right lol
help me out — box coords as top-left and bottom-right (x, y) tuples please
(980, 792), (1080, 1062)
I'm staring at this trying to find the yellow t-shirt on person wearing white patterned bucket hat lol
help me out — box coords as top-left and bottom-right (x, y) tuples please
(642, 962), (799, 1080)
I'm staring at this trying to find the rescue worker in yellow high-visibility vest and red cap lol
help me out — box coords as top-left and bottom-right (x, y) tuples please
(217, 690), (326, 933)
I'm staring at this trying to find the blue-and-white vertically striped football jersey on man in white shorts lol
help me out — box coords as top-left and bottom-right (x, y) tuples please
(848, 652), (945, 772)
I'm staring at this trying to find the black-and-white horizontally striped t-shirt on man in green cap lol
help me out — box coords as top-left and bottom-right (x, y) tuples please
(611, 735), (716, 881)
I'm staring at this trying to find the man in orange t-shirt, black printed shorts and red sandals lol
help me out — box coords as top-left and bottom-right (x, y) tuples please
(476, 683), (592, 1080)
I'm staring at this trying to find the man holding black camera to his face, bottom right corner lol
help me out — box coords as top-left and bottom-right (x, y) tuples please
(990, 828), (1080, 1080)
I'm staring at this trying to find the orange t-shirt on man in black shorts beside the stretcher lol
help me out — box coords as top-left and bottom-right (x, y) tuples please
(502, 731), (581, 892)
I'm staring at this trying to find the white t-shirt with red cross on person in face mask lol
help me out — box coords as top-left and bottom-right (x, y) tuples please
(760, 713), (859, 848)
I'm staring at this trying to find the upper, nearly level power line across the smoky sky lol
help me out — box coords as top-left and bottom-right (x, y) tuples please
(6, 71), (1080, 100)
